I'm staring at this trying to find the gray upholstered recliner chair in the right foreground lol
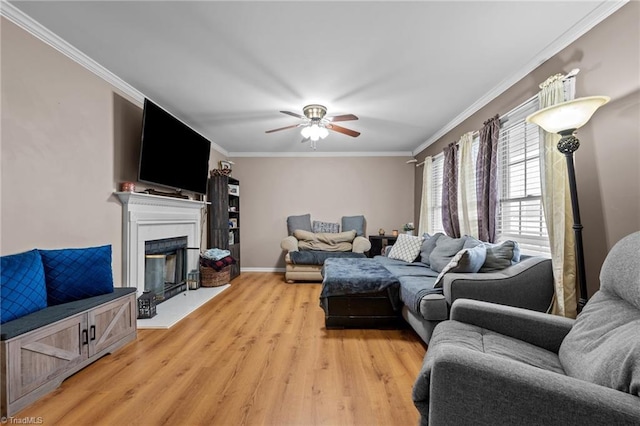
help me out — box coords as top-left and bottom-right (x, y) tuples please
(413, 232), (640, 426)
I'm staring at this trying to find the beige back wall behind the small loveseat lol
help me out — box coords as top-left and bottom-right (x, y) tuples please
(233, 157), (415, 268)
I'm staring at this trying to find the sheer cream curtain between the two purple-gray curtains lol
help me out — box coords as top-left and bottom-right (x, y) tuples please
(458, 132), (478, 238)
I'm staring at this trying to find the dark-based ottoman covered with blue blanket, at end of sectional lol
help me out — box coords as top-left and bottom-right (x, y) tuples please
(320, 258), (404, 328)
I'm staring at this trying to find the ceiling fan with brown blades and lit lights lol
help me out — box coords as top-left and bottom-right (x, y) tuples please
(265, 104), (360, 149)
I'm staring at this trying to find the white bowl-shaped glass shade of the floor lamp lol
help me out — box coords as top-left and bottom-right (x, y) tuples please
(527, 96), (610, 133)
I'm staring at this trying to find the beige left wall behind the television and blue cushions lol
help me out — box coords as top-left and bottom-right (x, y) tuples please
(0, 18), (224, 285)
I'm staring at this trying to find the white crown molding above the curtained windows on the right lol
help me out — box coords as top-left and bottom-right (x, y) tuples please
(412, 0), (629, 156)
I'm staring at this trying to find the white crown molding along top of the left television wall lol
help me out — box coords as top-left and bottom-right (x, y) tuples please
(0, 0), (229, 156)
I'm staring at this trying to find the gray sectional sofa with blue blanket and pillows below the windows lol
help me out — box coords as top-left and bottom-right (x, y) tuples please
(320, 234), (554, 343)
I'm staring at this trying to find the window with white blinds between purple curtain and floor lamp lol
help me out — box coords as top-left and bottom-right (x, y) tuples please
(498, 97), (550, 254)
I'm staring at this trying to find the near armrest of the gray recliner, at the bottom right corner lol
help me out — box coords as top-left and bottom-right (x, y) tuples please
(424, 347), (640, 425)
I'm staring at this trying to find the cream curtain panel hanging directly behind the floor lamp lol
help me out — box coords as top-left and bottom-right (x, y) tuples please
(538, 74), (577, 318)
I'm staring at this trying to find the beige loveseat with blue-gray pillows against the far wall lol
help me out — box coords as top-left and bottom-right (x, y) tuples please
(280, 214), (371, 282)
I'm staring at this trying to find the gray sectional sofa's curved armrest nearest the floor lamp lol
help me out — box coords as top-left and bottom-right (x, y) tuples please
(442, 257), (554, 312)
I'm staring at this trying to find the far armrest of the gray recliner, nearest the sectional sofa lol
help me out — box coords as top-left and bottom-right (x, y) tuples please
(451, 299), (575, 353)
